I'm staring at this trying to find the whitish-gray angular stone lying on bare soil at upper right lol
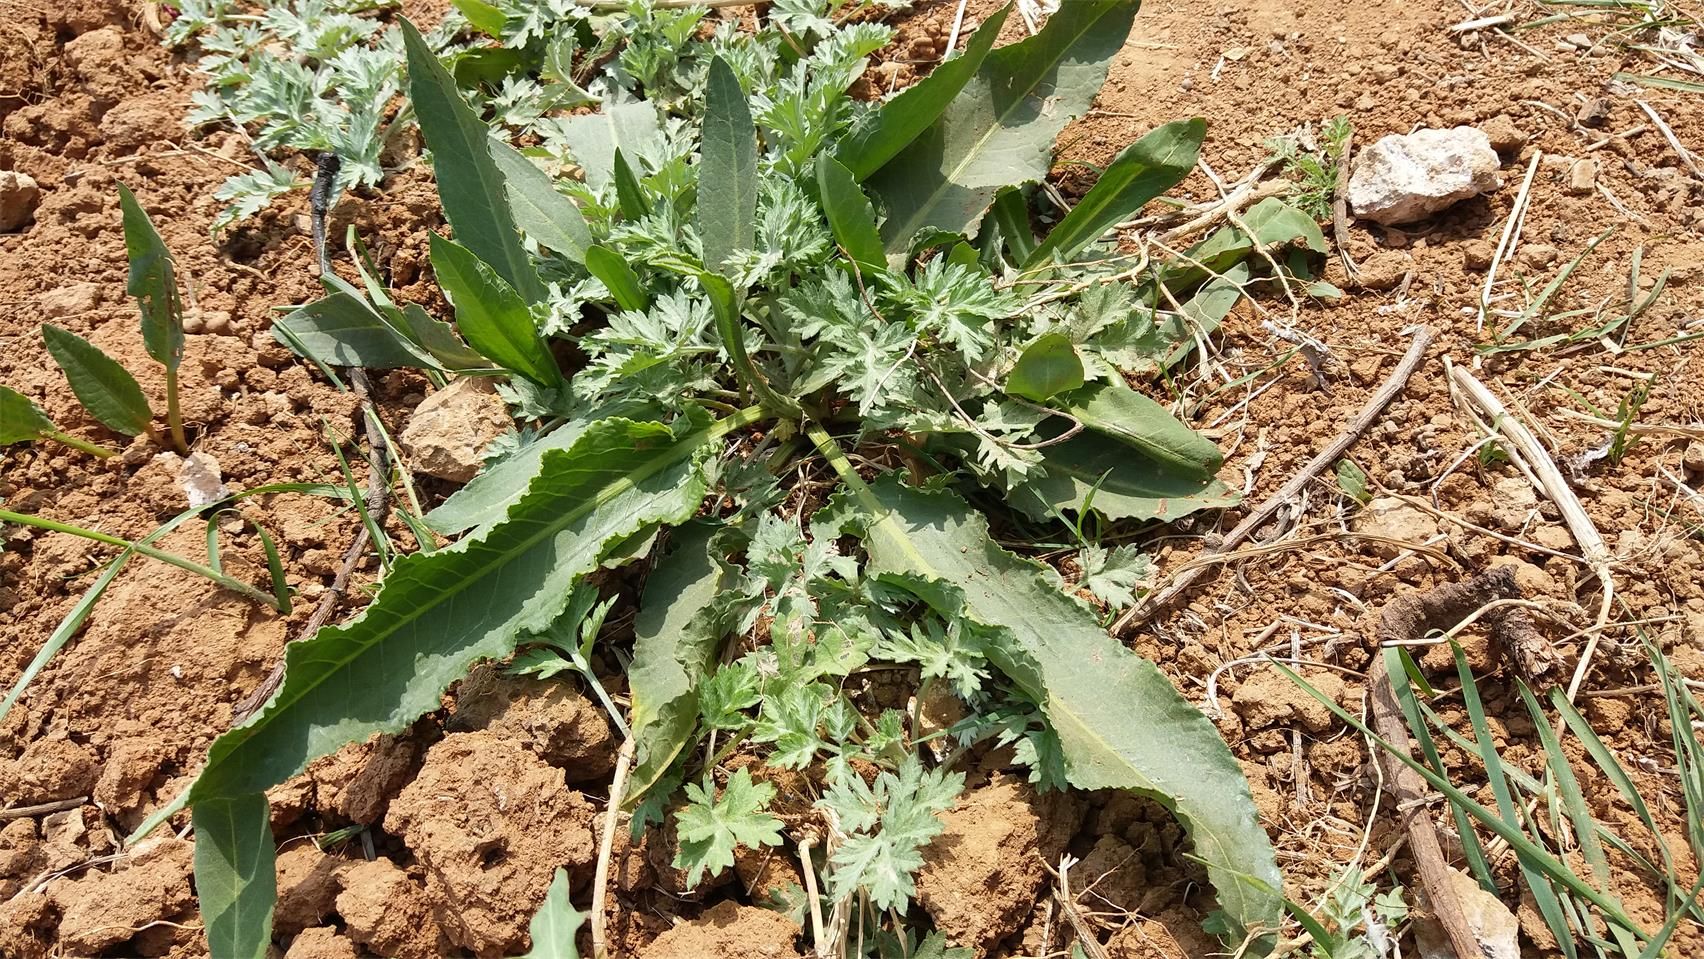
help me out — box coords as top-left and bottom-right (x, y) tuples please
(1350, 126), (1501, 225)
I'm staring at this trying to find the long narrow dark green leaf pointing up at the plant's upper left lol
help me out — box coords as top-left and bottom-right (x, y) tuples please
(402, 17), (544, 303)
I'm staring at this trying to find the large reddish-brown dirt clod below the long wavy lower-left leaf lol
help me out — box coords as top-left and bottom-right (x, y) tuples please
(385, 732), (596, 959)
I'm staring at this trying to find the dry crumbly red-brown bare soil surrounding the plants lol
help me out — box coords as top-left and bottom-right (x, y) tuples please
(0, 0), (1704, 959)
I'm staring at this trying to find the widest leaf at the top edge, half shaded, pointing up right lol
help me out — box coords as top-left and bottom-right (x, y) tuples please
(854, 0), (1138, 252)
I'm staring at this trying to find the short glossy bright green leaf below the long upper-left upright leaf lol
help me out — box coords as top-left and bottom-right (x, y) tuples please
(431, 233), (562, 387)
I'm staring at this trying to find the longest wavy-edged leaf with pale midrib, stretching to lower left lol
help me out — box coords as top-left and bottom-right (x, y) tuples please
(172, 409), (757, 814)
